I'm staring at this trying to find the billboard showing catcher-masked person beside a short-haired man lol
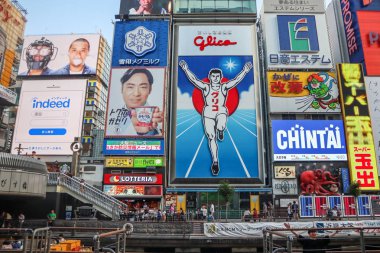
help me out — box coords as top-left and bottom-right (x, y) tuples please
(18, 34), (100, 78)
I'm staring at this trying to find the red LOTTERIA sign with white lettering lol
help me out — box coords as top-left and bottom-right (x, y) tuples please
(104, 174), (162, 184)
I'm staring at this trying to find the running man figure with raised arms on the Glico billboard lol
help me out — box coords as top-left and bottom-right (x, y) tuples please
(179, 60), (252, 176)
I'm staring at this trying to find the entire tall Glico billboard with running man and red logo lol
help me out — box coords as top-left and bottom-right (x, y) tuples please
(171, 26), (261, 184)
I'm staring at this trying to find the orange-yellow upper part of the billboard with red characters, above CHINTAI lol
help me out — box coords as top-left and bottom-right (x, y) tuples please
(267, 71), (335, 97)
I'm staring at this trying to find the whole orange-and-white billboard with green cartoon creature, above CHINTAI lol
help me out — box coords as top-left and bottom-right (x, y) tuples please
(267, 71), (340, 113)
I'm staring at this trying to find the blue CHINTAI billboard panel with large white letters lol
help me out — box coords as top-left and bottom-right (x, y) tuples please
(272, 120), (347, 160)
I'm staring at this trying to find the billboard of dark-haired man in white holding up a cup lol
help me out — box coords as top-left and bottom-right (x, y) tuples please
(105, 68), (165, 138)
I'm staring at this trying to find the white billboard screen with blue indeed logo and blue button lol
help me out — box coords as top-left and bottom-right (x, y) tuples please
(12, 79), (87, 155)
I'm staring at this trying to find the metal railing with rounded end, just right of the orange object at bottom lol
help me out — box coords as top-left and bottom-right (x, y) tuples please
(94, 223), (133, 253)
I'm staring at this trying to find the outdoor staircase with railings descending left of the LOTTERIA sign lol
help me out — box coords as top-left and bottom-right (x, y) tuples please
(48, 173), (126, 220)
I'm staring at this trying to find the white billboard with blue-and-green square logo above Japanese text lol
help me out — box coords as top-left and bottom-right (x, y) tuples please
(263, 14), (334, 69)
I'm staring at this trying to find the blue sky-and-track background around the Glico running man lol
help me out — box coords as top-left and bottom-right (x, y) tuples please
(175, 56), (259, 179)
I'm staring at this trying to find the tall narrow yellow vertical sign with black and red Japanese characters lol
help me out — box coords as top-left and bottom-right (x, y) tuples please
(337, 64), (379, 191)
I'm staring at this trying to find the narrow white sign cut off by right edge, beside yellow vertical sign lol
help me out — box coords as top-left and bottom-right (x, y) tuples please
(365, 76), (380, 173)
